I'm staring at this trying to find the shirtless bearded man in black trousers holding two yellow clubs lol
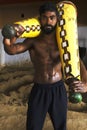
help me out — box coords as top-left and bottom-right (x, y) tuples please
(3, 3), (87, 130)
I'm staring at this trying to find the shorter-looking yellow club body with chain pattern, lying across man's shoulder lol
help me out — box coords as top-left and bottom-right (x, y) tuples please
(14, 18), (41, 38)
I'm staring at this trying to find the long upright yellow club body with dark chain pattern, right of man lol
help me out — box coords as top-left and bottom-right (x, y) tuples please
(56, 1), (80, 79)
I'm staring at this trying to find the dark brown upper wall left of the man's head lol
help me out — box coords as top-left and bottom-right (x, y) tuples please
(0, 2), (42, 28)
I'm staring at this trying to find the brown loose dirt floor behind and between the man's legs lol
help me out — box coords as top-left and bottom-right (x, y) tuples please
(0, 63), (87, 130)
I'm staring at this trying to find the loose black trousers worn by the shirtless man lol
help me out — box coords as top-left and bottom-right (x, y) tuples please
(26, 80), (67, 130)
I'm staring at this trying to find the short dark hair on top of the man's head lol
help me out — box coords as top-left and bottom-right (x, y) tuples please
(39, 2), (58, 16)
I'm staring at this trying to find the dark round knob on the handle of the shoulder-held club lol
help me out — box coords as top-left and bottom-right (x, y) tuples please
(2, 24), (16, 39)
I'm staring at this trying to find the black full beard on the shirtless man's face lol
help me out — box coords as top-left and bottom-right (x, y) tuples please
(41, 24), (57, 34)
